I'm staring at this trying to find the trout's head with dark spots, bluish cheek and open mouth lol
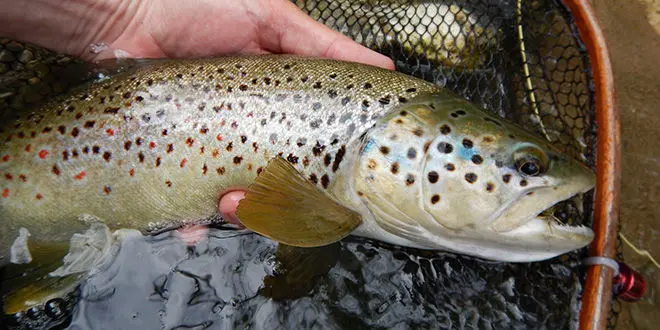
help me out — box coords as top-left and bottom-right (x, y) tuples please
(356, 94), (595, 261)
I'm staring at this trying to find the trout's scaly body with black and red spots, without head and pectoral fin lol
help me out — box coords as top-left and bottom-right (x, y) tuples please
(0, 56), (439, 258)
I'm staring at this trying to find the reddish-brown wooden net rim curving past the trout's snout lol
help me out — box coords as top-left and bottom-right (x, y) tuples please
(562, 0), (621, 330)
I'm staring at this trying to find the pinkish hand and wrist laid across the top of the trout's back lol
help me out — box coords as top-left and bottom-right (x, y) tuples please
(0, 0), (393, 69)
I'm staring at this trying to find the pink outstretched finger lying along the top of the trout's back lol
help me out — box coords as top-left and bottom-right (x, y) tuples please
(265, 1), (394, 70)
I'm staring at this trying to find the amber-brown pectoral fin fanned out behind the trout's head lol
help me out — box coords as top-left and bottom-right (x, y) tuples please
(236, 157), (362, 247)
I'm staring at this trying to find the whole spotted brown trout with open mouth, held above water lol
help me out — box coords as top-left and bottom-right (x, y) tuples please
(0, 55), (595, 310)
